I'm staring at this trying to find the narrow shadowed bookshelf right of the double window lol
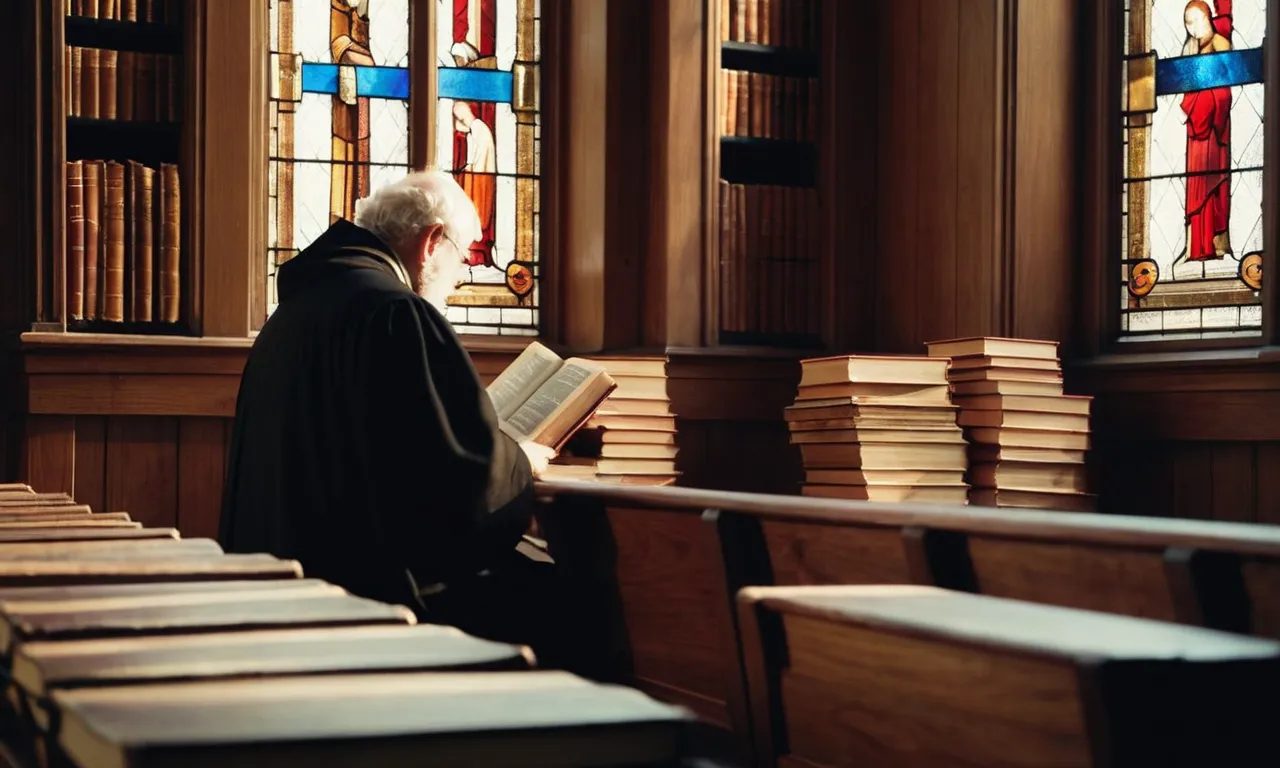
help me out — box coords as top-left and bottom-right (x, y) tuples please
(708, 0), (828, 348)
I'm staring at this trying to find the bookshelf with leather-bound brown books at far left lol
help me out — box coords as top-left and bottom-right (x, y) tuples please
(49, 0), (196, 335)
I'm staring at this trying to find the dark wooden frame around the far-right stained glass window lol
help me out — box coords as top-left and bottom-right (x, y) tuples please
(1078, 0), (1280, 366)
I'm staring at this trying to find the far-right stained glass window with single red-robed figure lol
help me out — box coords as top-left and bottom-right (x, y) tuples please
(1119, 0), (1267, 339)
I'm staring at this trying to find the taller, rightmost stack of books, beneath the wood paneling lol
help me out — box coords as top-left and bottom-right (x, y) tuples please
(927, 338), (1094, 512)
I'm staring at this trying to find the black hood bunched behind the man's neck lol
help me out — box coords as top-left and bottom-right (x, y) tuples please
(275, 219), (410, 303)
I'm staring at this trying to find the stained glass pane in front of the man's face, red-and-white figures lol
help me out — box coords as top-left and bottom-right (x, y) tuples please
(435, 0), (541, 334)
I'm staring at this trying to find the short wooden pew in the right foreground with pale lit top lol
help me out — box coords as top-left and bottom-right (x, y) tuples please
(739, 586), (1280, 768)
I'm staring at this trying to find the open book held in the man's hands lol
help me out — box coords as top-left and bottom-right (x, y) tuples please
(489, 342), (617, 451)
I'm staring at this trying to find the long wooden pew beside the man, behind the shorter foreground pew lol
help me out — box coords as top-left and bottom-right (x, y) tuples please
(538, 481), (1280, 737)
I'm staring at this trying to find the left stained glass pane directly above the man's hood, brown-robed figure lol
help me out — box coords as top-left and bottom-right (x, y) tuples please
(268, 0), (410, 312)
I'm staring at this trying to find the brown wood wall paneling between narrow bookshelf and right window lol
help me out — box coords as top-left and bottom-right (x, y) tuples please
(875, 0), (1078, 353)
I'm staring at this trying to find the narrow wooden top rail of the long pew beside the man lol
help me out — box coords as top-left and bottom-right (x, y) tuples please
(535, 480), (1280, 557)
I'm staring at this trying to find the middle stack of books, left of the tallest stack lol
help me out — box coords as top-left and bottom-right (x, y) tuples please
(786, 356), (969, 504)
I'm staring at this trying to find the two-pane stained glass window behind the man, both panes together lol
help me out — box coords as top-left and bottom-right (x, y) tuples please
(268, 0), (541, 335)
